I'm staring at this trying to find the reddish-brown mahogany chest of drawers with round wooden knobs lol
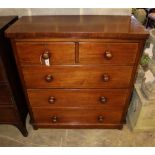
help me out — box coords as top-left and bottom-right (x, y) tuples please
(6, 15), (148, 129)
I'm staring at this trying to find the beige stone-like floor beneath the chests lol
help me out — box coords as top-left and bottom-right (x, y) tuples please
(0, 116), (155, 147)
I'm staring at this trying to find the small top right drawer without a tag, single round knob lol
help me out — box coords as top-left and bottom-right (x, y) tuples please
(79, 43), (138, 65)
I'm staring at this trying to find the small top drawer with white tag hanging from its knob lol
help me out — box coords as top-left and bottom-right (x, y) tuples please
(16, 42), (75, 65)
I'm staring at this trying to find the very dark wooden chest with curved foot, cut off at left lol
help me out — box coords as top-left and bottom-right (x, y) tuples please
(0, 16), (28, 136)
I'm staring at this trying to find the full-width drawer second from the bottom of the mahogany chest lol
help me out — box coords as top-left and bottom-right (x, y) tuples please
(28, 89), (128, 109)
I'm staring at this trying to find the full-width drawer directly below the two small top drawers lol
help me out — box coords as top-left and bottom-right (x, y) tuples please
(23, 66), (132, 89)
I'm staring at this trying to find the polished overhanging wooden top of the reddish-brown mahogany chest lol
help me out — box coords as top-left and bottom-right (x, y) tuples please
(6, 15), (148, 39)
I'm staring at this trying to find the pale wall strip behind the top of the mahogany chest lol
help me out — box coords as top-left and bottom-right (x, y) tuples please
(0, 8), (131, 16)
